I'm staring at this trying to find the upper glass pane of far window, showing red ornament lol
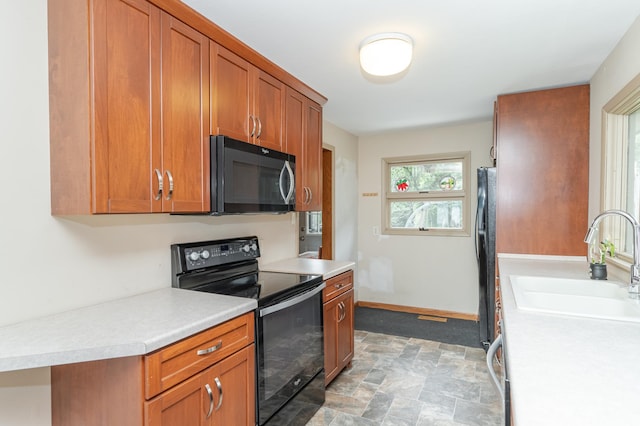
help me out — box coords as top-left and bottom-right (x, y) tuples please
(389, 161), (464, 193)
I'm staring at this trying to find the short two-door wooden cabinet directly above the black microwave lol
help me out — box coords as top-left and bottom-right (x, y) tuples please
(211, 42), (285, 151)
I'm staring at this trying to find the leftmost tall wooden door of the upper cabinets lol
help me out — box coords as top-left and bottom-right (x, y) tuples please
(92, 0), (161, 213)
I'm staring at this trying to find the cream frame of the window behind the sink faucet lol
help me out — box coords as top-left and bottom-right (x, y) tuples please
(599, 74), (640, 270)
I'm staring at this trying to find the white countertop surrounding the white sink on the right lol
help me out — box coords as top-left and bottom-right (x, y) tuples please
(499, 255), (640, 426)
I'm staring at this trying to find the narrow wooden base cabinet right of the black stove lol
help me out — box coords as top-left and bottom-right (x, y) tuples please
(322, 271), (354, 385)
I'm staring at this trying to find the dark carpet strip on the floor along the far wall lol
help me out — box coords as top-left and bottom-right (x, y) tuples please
(355, 307), (482, 348)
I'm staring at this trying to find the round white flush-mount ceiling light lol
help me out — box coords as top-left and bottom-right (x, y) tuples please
(360, 33), (413, 76)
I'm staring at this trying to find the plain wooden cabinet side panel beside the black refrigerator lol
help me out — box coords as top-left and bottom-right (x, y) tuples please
(496, 85), (589, 256)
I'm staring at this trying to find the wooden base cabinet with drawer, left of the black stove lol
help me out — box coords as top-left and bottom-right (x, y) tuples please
(51, 312), (256, 426)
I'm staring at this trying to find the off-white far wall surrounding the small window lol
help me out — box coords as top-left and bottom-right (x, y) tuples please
(358, 121), (493, 314)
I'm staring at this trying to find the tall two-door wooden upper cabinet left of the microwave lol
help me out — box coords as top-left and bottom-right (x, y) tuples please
(49, 0), (209, 214)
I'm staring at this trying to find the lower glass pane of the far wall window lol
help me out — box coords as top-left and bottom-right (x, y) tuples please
(390, 200), (462, 229)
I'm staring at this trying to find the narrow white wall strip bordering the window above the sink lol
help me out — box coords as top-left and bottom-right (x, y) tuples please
(589, 17), (640, 219)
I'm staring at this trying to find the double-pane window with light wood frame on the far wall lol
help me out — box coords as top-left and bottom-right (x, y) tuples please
(383, 152), (470, 236)
